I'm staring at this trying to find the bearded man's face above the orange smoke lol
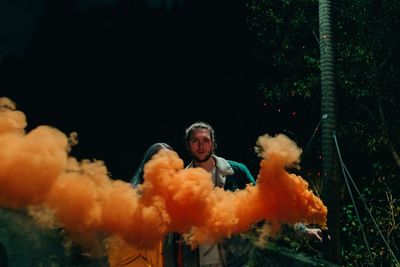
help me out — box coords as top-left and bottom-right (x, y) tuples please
(188, 129), (214, 162)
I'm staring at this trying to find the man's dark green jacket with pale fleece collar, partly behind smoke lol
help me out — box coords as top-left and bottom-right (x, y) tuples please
(164, 155), (256, 267)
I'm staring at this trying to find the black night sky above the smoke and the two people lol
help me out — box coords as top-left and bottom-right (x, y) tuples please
(0, 0), (316, 181)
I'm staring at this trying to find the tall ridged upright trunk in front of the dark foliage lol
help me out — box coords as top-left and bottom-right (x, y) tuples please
(319, 0), (341, 263)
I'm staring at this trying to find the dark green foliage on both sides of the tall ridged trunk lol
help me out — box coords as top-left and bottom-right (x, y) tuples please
(246, 0), (400, 266)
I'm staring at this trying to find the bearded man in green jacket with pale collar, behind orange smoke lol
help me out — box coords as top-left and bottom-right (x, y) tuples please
(169, 122), (321, 267)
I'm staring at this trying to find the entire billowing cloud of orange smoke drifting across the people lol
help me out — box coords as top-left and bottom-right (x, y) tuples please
(0, 98), (327, 254)
